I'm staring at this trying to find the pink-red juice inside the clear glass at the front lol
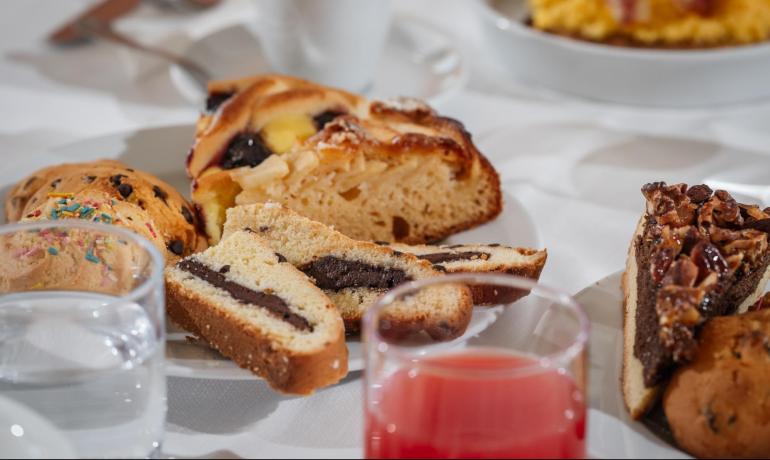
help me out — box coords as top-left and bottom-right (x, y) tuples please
(365, 349), (586, 458)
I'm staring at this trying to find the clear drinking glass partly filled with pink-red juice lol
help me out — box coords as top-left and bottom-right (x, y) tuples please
(364, 274), (588, 458)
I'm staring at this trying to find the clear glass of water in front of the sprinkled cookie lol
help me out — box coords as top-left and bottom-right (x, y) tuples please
(0, 220), (166, 458)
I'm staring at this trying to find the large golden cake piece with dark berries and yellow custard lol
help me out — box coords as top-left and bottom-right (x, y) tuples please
(187, 75), (502, 243)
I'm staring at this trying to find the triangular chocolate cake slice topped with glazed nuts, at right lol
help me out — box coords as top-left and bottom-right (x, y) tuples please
(622, 182), (770, 418)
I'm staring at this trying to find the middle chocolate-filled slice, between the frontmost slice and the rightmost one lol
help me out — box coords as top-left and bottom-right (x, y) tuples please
(224, 203), (473, 340)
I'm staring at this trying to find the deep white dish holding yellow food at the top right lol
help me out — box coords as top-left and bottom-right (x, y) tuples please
(477, 0), (770, 108)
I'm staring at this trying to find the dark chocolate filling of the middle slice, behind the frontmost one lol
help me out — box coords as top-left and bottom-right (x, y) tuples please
(299, 256), (412, 291)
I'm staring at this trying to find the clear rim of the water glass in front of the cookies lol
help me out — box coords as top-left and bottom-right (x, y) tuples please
(0, 219), (165, 305)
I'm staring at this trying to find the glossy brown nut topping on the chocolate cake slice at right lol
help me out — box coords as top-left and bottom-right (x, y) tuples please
(642, 182), (770, 363)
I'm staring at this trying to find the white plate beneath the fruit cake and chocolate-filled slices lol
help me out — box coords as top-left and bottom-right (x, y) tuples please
(0, 125), (541, 380)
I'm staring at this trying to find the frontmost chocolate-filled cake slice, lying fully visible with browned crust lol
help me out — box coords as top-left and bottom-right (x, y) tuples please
(166, 231), (348, 394)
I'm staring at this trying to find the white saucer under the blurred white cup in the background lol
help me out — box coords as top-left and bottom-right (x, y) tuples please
(170, 16), (468, 106)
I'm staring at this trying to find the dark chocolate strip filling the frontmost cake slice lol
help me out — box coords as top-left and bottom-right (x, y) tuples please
(176, 259), (313, 332)
